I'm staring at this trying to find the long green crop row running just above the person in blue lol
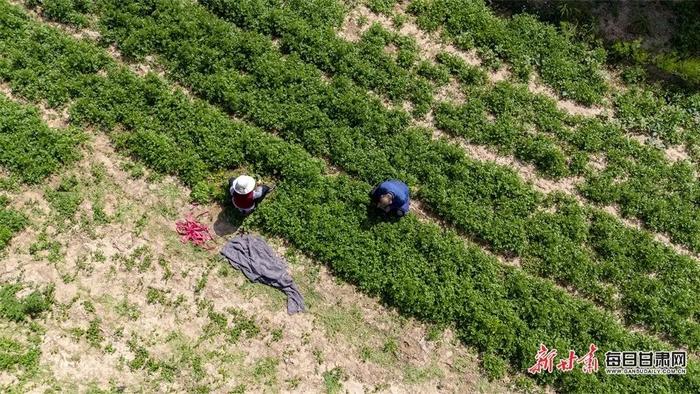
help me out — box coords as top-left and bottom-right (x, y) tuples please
(47, 2), (700, 348)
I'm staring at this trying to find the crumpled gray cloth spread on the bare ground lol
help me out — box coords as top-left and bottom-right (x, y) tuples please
(221, 235), (305, 314)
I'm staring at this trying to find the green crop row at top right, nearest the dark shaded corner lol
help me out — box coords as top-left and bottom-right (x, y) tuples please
(408, 0), (607, 104)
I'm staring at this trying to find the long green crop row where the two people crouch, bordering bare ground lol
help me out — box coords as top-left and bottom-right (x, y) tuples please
(0, 1), (700, 391)
